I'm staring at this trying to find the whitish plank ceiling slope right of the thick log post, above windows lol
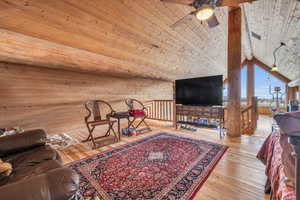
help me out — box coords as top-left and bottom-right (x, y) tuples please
(244, 0), (300, 80)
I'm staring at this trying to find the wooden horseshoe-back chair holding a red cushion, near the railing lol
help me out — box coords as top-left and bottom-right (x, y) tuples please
(125, 99), (151, 132)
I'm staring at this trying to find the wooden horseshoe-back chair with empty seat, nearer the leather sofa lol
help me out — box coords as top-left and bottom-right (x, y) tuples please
(82, 100), (118, 149)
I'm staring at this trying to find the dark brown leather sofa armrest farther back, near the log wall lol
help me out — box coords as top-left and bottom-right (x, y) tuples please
(0, 129), (46, 157)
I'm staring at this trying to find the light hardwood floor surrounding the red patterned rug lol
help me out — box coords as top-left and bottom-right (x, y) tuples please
(60, 116), (271, 200)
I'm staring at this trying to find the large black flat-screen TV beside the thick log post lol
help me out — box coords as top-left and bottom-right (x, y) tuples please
(176, 75), (223, 106)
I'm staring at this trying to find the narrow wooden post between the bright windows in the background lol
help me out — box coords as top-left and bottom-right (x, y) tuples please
(247, 61), (255, 105)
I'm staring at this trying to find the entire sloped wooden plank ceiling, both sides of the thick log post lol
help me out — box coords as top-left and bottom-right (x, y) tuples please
(0, 0), (300, 80)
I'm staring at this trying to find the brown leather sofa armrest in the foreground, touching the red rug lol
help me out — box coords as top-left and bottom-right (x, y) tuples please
(0, 168), (79, 200)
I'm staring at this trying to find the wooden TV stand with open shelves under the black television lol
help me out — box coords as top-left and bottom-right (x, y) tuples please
(176, 105), (224, 137)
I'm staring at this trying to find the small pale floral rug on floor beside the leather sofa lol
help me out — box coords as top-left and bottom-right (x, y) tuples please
(46, 133), (79, 150)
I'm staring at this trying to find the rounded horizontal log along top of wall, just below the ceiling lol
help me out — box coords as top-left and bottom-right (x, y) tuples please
(0, 29), (175, 80)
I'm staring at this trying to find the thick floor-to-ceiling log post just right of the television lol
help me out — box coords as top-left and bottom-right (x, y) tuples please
(227, 7), (242, 137)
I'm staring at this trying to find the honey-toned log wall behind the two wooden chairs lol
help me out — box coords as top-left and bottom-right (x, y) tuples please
(0, 63), (173, 134)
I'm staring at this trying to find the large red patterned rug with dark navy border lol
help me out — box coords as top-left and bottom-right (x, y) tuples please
(69, 133), (227, 200)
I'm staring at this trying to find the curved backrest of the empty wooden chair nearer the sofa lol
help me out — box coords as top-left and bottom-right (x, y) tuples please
(85, 100), (114, 121)
